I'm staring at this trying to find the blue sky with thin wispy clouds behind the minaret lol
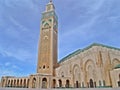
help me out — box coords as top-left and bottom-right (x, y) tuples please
(0, 0), (120, 77)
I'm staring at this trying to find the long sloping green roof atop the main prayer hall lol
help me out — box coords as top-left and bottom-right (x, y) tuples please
(59, 43), (120, 63)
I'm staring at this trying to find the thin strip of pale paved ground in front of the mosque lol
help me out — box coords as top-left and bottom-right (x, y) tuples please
(0, 88), (120, 90)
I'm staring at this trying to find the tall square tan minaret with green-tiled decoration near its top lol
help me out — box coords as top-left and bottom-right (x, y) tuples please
(37, 0), (58, 75)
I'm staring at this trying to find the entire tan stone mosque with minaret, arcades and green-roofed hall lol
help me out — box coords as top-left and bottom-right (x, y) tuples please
(1, 0), (120, 88)
